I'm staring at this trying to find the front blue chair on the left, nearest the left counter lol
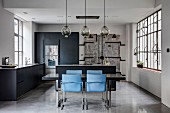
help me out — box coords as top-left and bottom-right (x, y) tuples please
(61, 74), (84, 109)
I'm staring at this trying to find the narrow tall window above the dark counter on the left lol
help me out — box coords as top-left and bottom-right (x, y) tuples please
(14, 18), (23, 65)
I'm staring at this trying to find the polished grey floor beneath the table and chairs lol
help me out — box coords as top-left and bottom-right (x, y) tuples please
(0, 82), (170, 113)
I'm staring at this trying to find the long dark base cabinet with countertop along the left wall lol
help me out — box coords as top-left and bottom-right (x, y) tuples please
(0, 64), (45, 101)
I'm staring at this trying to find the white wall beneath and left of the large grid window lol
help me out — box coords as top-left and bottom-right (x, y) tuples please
(126, 21), (161, 98)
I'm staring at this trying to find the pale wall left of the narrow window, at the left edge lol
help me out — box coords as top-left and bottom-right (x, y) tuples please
(0, 0), (14, 64)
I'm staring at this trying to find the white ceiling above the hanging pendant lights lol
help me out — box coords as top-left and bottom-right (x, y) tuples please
(4, 0), (159, 24)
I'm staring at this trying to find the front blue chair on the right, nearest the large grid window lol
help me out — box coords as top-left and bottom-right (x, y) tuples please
(85, 74), (107, 110)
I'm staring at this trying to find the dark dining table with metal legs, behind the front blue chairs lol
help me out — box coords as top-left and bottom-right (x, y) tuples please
(42, 74), (126, 108)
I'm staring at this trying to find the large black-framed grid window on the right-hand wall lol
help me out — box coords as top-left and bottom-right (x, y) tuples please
(137, 10), (161, 70)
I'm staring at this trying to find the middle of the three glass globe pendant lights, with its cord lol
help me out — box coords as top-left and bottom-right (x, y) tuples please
(81, 0), (90, 38)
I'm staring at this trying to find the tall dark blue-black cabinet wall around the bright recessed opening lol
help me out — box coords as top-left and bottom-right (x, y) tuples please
(35, 32), (79, 64)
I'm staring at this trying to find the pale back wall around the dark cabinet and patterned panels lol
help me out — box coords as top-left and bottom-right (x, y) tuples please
(37, 24), (126, 75)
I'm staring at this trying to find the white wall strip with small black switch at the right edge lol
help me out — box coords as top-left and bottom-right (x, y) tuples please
(162, 0), (170, 107)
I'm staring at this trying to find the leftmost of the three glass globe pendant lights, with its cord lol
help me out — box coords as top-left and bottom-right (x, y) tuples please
(61, 0), (71, 38)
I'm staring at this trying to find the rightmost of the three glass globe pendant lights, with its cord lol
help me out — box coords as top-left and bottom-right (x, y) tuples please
(100, 0), (110, 38)
